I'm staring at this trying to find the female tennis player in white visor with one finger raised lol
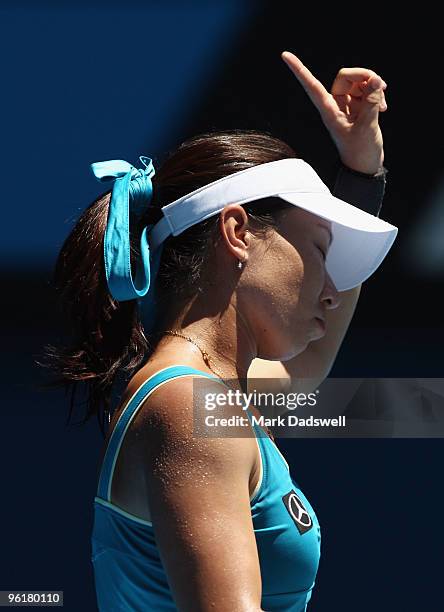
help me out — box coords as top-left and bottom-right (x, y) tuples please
(41, 52), (397, 612)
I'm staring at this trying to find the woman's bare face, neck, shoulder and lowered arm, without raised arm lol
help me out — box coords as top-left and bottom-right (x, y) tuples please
(107, 205), (339, 612)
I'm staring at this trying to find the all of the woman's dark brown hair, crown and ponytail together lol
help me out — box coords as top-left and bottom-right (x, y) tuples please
(37, 130), (296, 434)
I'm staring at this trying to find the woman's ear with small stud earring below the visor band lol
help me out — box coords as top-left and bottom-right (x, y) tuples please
(219, 204), (251, 261)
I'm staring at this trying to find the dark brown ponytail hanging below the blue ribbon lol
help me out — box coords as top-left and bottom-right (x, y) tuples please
(37, 192), (148, 433)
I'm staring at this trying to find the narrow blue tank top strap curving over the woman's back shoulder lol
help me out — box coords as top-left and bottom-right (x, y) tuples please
(97, 365), (219, 501)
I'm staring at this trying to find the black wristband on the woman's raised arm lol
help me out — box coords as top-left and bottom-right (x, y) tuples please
(332, 162), (388, 217)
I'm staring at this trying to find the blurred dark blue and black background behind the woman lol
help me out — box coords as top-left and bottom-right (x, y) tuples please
(0, 1), (444, 612)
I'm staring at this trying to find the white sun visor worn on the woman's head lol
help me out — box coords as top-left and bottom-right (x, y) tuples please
(148, 158), (398, 291)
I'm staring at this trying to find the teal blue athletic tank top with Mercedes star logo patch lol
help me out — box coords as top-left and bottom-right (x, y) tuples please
(91, 365), (321, 612)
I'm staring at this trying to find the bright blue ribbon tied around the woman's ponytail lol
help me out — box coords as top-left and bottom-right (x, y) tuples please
(91, 155), (162, 302)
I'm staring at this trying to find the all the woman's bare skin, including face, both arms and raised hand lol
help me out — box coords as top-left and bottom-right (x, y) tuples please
(104, 52), (387, 612)
